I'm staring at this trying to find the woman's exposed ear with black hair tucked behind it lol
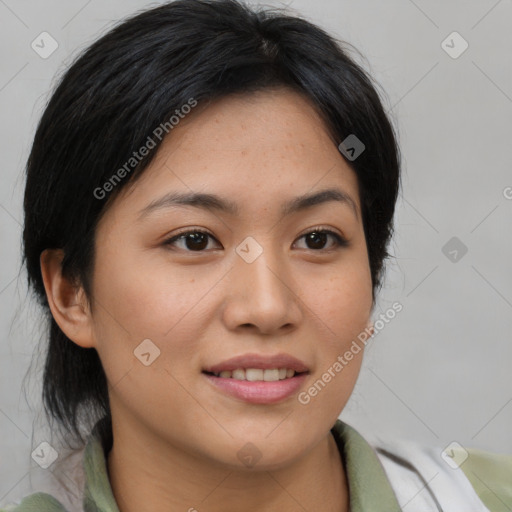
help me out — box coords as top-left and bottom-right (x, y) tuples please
(40, 249), (95, 348)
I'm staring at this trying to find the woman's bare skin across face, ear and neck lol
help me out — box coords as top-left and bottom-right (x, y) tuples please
(41, 89), (373, 512)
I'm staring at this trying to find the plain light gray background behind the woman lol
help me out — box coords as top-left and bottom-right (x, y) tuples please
(0, 0), (512, 503)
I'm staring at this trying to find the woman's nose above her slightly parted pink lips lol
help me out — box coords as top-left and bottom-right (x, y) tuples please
(223, 244), (303, 334)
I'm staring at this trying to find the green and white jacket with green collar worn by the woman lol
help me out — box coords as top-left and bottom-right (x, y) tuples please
(0, 420), (512, 512)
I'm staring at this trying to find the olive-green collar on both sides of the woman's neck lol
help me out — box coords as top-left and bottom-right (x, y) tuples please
(84, 420), (400, 512)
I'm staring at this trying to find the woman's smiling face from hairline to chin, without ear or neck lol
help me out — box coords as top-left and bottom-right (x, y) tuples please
(85, 89), (372, 468)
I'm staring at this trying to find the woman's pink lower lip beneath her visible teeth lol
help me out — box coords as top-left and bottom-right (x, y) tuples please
(203, 373), (307, 404)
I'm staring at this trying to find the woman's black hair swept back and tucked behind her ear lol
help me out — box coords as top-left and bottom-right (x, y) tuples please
(23, 0), (400, 442)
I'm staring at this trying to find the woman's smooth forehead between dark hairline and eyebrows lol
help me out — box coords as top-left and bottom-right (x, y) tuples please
(105, 89), (359, 221)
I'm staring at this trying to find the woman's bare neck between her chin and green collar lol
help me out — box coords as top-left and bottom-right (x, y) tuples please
(107, 422), (349, 512)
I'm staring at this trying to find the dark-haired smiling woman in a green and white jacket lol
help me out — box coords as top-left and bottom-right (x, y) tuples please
(5, 0), (512, 512)
